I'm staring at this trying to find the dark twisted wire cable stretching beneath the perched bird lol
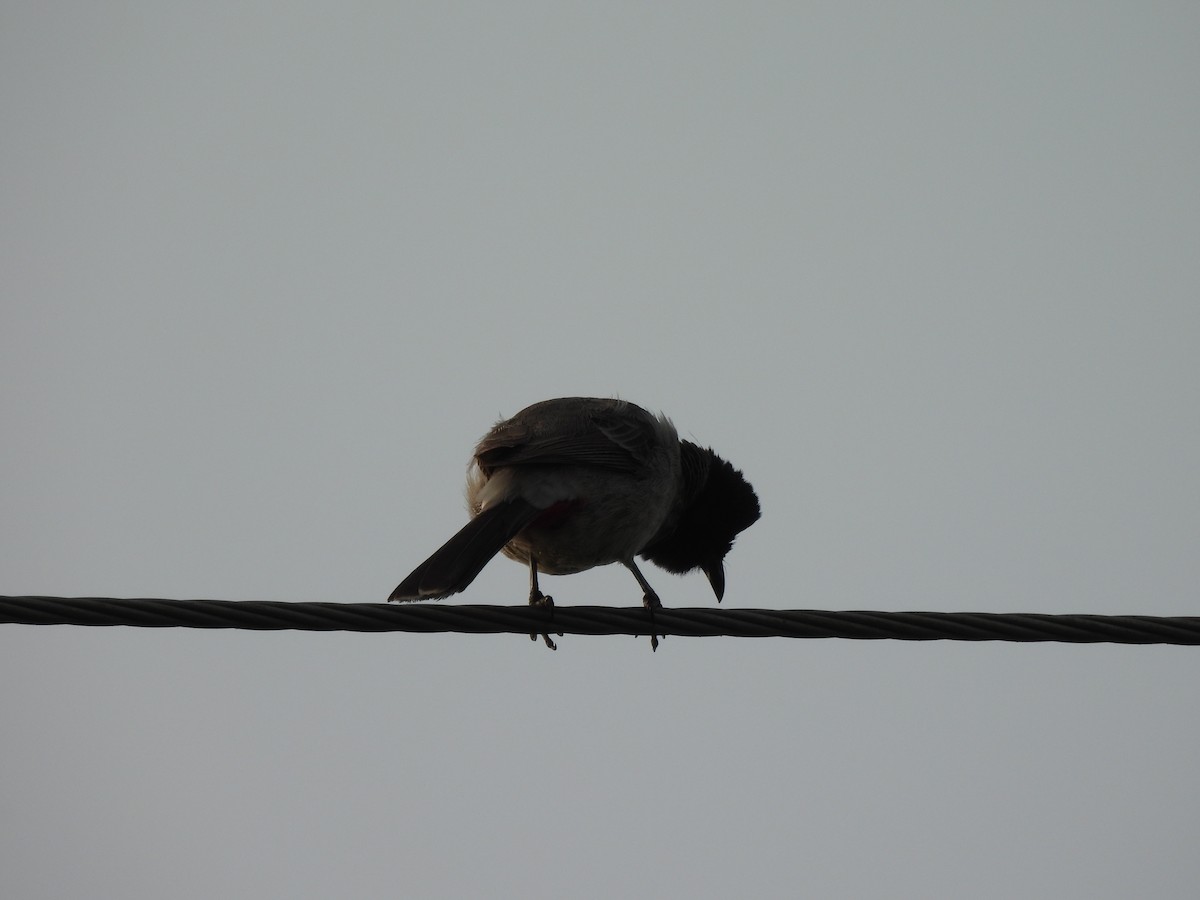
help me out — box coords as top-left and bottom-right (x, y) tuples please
(0, 596), (1200, 646)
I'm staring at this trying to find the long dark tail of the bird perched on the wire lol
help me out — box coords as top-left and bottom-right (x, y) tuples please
(388, 499), (541, 601)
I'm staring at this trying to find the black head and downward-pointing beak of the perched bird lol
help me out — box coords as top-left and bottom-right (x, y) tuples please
(641, 440), (761, 602)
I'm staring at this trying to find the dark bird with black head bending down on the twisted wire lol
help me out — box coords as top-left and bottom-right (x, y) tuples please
(388, 397), (761, 649)
